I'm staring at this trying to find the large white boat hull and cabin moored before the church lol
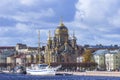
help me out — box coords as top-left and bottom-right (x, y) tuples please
(26, 64), (61, 75)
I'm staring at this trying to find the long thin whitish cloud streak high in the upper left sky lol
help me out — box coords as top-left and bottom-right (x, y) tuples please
(3, 8), (55, 22)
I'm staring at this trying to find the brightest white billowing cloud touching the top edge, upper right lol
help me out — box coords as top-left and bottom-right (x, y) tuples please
(75, 0), (118, 21)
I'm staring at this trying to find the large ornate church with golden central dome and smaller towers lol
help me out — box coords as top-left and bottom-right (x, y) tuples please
(44, 21), (80, 63)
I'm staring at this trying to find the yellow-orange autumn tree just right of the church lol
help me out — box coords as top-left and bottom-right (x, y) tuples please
(83, 50), (93, 63)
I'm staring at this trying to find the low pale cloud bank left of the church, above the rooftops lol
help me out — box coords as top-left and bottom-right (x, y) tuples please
(0, 20), (54, 46)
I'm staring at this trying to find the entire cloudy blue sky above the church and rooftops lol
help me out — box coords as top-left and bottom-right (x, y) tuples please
(0, 0), (120, 46)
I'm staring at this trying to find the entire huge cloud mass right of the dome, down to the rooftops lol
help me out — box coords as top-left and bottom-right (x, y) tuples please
(73, 0), (120, 44)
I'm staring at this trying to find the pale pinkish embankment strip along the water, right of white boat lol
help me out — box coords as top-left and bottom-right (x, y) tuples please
(57, 71), (120, 77)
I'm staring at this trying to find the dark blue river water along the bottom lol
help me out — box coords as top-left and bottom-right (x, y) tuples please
(0, 73), (120, 80)
